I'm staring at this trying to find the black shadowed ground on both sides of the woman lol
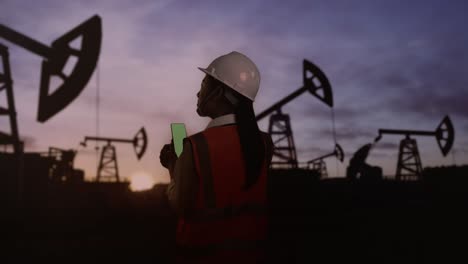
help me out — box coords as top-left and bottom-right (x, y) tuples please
(0, 168), (468, 263)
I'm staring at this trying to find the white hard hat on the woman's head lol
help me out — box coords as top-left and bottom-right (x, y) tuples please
(198, 51), (260, 101)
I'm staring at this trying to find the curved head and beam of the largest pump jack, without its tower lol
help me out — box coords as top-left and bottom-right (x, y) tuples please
(0, 15), (102, 123)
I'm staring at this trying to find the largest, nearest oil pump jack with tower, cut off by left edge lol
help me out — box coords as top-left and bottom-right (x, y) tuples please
(0, 16), (102, 153)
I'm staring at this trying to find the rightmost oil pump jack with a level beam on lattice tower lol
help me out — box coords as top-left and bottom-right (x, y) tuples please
(375, 116), (455, 180)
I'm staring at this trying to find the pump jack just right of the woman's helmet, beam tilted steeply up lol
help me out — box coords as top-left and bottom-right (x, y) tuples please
(256, 60), (333, 169)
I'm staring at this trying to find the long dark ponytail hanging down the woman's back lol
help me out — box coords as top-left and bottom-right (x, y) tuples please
(234, 95), (265, 190)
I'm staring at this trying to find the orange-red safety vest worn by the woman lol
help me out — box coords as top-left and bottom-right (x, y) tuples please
(176, 125), (272, 263)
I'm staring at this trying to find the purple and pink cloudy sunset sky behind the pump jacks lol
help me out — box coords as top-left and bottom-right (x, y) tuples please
(0, 0), (468, 182)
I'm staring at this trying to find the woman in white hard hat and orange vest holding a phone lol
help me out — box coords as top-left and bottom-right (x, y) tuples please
(160, 52), (272, 263)
